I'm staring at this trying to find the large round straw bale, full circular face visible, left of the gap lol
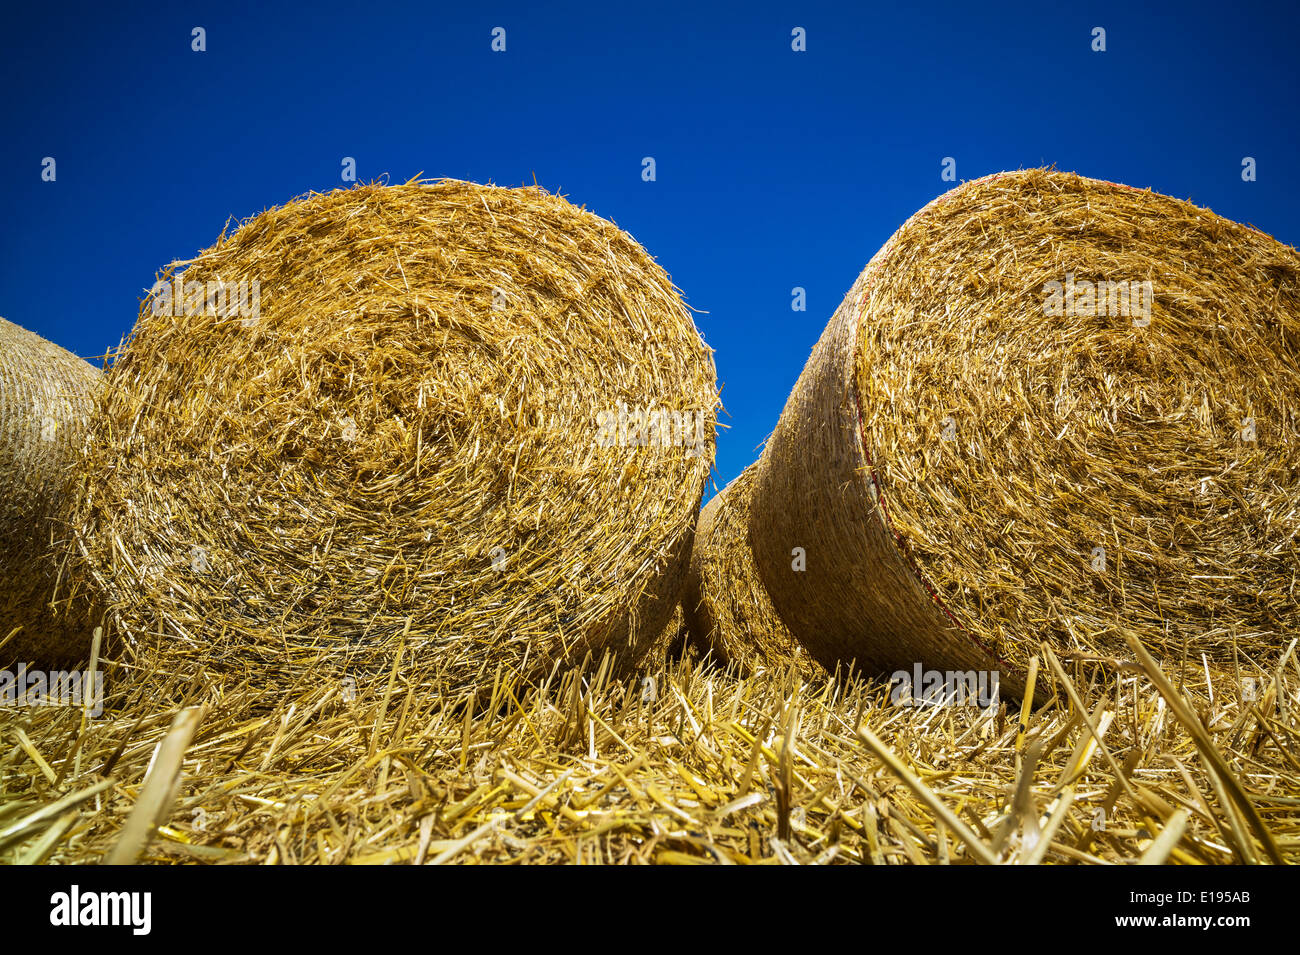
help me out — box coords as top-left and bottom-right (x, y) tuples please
(79, 181), (718, 691)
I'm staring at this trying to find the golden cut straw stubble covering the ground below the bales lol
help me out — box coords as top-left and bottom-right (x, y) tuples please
(0, 634), (1300, 864)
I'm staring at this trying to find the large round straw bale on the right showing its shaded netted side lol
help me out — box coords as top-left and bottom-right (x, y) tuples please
(751, 170), (1300, 693)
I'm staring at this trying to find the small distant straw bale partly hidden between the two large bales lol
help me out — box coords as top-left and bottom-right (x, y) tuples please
(681, 464), (822, 678)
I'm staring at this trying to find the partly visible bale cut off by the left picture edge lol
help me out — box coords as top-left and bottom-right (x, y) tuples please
(0, 318), (103, 664)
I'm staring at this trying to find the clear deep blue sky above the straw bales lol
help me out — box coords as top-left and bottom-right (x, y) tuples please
(0, 1), (1300, 493)
